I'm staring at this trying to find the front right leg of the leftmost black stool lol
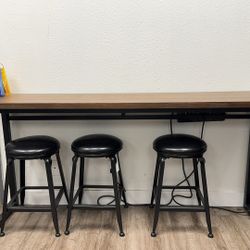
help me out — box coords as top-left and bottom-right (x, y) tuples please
(44, 158), (60, 237)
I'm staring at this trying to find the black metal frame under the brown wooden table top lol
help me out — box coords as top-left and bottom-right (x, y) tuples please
(0, 108), (250, 222)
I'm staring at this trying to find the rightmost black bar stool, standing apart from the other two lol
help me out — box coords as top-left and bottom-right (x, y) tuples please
(150, 134), (213, 238)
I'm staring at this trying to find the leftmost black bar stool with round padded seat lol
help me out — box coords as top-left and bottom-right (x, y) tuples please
(0, 135), (69, 237)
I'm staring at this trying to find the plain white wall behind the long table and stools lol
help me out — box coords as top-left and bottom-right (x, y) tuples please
(0, 0), (250, 205)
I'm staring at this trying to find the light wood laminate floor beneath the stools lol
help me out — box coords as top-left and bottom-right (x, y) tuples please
(0, 207), (250, 250)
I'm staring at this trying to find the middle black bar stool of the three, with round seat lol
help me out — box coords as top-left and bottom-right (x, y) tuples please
(65, 134), (128, 236)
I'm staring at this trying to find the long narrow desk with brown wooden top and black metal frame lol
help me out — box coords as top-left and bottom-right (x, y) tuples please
(0, 91), (250, 221)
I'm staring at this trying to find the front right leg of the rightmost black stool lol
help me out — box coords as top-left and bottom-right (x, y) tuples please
(199, 158), (214, 238)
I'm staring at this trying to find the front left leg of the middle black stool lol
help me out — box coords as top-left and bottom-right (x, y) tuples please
(64, 156), (78, 235)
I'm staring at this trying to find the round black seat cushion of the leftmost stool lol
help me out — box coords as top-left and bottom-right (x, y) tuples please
(6, 135), (60, 159)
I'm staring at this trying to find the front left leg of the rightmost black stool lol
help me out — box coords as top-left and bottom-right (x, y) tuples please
(151, 157), (166, 237)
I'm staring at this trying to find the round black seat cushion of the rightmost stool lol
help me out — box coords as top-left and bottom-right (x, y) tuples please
(153, 134), (207, 158)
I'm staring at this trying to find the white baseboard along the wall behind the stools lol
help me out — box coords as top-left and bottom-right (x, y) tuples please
(21, 189), (243, 206)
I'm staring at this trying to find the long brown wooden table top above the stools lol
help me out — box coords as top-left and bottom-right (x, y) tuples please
(0, 91), (250, 110)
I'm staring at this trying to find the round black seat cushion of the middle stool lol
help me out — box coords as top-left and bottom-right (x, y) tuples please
(71, 134), (122, 157)
